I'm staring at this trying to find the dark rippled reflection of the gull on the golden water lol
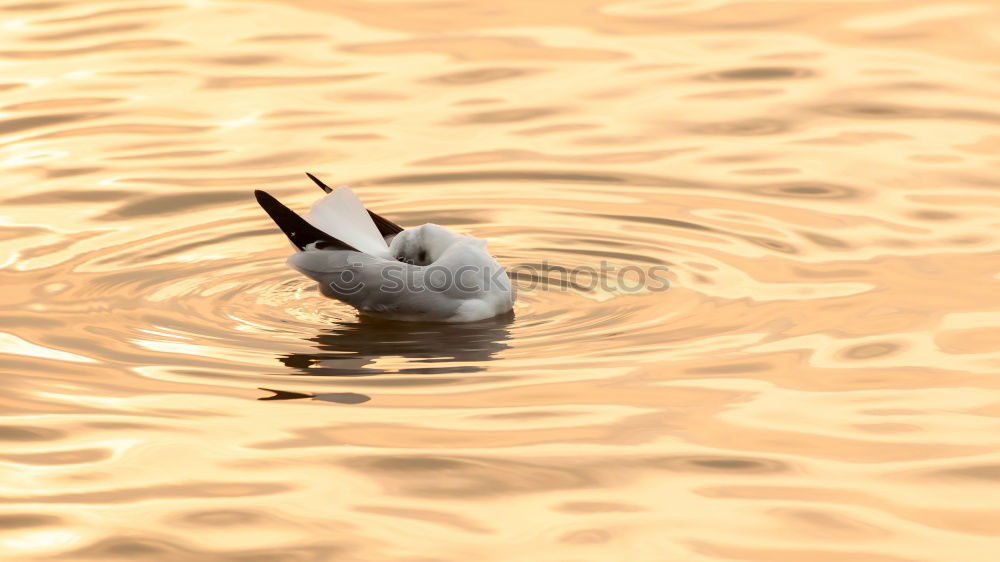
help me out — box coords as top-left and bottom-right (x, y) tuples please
(258, 313), (514, 404)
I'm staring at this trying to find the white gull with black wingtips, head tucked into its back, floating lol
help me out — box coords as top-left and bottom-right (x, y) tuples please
(254, 174), (514, 322)
